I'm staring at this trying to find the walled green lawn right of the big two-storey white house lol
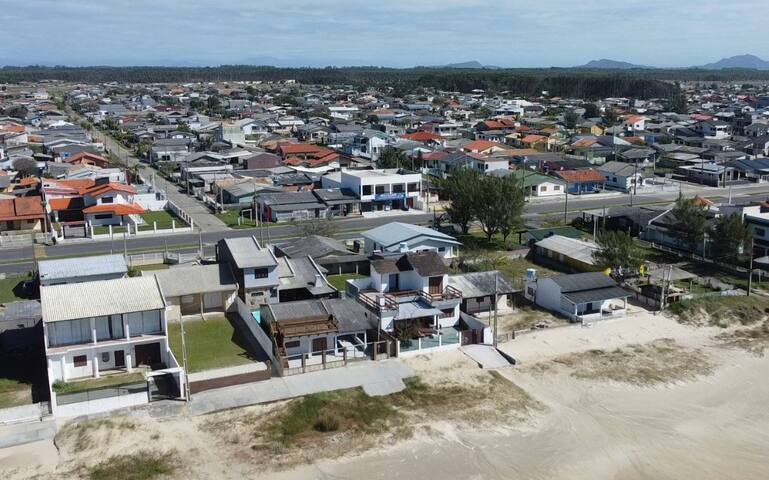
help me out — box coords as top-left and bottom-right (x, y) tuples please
(168, 318), (253, 372)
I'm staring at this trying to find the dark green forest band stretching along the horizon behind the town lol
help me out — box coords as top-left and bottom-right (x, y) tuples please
(0, 65), (708, 99)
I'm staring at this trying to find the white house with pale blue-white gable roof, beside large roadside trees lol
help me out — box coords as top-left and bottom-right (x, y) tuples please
(361, 222), (462, 259)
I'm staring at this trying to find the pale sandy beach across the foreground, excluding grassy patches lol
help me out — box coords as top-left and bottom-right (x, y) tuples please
(0, 314), (769, 480)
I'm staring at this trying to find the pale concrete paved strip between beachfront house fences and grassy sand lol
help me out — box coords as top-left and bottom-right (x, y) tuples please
(189, 359), (414, 415)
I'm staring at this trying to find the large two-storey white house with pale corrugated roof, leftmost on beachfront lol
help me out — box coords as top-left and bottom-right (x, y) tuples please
(40, 276), (183, 413)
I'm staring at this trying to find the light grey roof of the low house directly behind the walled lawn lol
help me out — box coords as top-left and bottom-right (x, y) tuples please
(150, 263), (238, 298)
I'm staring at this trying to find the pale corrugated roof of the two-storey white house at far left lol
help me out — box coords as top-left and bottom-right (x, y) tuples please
(40, 275), (166, 322)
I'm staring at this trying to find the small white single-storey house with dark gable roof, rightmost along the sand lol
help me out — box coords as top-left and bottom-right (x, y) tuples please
(524, 270), (630, 322)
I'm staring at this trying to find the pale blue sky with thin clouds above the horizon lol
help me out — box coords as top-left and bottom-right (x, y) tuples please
(0, 0), (769, 67)
